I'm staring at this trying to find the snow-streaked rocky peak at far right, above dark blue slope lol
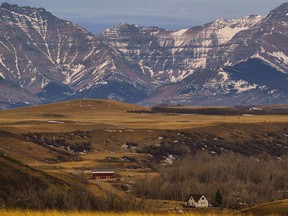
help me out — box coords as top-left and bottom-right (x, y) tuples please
(208, 3), (288, 73)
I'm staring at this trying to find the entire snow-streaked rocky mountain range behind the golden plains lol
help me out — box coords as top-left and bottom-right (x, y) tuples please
(0, 3), (288, 109)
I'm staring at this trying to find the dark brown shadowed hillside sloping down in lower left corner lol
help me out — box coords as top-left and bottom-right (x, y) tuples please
(0, 154), (101, 210)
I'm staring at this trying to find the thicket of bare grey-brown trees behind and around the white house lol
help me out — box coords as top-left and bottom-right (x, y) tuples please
(134, 152), (288, 209)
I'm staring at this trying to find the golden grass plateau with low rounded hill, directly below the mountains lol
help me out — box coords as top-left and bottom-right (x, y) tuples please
(0, 100), (288, 132)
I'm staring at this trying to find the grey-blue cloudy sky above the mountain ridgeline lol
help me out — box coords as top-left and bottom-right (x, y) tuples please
(0, 0), (287, 33)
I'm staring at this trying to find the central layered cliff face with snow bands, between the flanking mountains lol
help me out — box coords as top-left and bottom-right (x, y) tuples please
(102, 16), (263, 83)
